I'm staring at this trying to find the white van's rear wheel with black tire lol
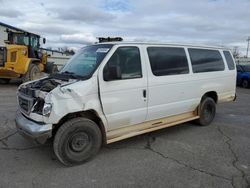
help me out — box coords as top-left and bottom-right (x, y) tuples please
(196, 97), (216, 126)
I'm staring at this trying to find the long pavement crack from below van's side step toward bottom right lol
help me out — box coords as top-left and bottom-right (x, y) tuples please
(145, 135), (231, 181)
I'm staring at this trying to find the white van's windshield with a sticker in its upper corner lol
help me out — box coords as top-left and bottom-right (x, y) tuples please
(60, 44), (113, 77)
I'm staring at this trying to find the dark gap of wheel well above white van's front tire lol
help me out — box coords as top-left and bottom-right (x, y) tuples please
(52, 110), (106, 143)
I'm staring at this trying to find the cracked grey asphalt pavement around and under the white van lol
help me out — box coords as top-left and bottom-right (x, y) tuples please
(0, 83), (250, 188)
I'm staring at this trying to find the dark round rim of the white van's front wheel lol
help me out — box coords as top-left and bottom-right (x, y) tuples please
(68, 132), (90, 152)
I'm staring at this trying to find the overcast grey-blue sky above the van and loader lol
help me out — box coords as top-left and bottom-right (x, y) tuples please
(0, 0), (250, 55)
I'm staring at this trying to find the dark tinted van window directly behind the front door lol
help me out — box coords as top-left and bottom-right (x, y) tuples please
(147, 47), (189, 76)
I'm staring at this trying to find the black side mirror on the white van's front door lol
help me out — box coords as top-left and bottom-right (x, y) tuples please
(103, 65), (121, 81)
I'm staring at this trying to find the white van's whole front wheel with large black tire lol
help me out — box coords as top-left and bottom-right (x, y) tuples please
(53, 117), (102, 166)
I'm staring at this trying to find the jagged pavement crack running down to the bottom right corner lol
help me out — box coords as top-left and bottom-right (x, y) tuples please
(216, 126), (250, 187)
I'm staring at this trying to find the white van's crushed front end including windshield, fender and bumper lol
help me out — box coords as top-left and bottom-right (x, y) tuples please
(16, 44), (113, 143)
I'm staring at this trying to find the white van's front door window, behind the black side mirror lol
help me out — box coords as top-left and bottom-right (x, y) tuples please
(103, 47), (142, 80)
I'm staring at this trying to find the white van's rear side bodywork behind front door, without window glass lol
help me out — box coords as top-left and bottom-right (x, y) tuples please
(144, 45), (236, 120)
